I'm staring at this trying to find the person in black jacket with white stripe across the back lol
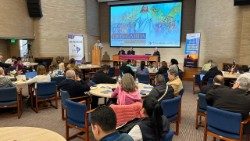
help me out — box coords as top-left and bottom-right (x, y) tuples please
(148, 74), (174, 101)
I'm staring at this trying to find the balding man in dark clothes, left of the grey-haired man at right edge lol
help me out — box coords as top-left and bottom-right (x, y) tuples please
(200, 75), (226, 94)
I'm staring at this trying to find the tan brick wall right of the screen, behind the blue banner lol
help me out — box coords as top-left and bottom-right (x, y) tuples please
(195, 0), (250, 66)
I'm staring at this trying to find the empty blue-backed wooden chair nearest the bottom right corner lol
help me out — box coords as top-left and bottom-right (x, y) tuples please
(204, 106), (249, 141)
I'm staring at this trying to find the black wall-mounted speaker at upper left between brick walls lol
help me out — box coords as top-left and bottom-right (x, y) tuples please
(26, 0), (43, 18)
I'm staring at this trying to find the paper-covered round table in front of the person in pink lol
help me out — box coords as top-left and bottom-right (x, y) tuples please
(89, 83), (153, 98)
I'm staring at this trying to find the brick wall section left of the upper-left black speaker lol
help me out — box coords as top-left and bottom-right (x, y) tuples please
(0, 0), (34, 38)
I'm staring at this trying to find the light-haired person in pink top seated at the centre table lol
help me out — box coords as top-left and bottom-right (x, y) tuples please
(111, 73), (142, 105)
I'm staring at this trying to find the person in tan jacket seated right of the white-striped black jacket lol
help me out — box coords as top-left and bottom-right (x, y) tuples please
(167, 66), (183, 96)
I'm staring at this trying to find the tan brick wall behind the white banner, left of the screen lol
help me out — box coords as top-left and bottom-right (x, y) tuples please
(32, 0), (95, 61)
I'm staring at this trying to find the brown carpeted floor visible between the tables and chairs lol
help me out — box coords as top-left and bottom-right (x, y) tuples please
(0, 82), (207, 141)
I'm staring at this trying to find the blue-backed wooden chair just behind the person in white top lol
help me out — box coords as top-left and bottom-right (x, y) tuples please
(31, 81), (58, 113)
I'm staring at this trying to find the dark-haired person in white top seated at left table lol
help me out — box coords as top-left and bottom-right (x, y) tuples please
(27, 65), (51, 84)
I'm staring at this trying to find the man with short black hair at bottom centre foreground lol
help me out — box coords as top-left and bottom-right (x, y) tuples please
(90, 106), (133, 141)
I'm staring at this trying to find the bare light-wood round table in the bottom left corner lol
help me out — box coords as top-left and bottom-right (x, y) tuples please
(0, 127), (66, 141)
